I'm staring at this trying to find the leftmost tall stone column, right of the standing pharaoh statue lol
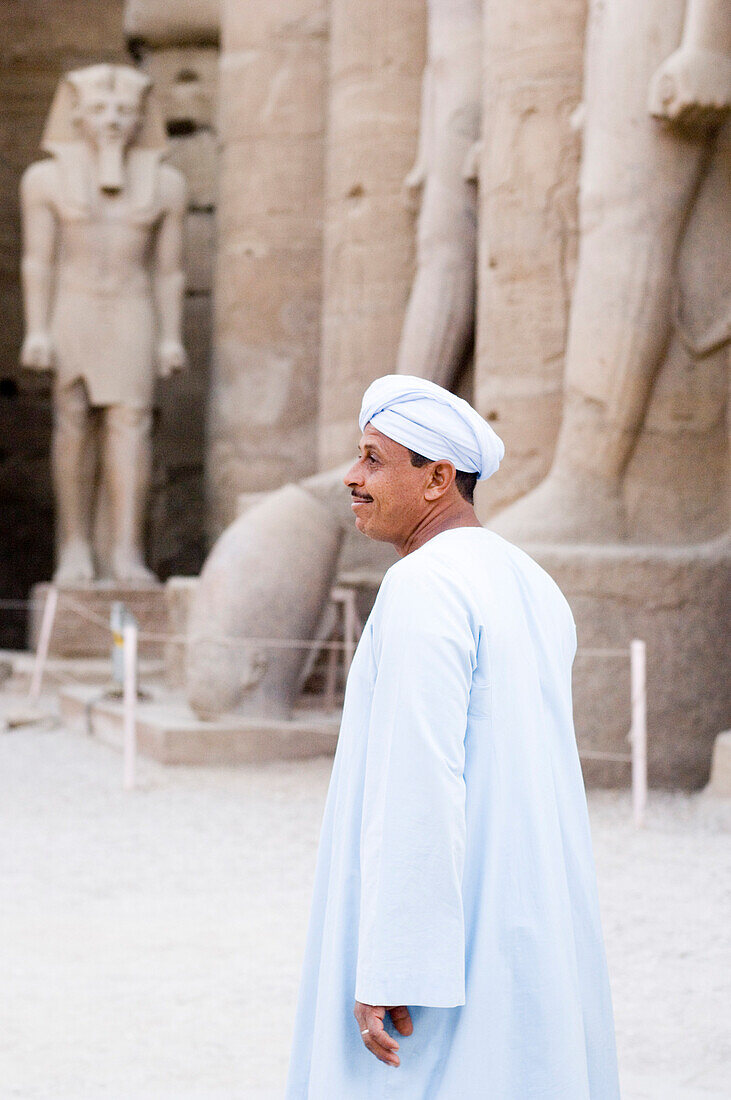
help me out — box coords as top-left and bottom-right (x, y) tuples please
(208, 0), (326, 531)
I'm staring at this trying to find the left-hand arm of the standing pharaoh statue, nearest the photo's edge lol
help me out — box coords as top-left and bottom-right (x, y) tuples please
(20, 161), (56, 371)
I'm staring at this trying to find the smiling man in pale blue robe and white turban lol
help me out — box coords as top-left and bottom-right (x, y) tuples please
(287, 375), (619, 1100)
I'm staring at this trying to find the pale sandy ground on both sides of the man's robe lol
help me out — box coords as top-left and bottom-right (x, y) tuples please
(0, 704), (731, 1100)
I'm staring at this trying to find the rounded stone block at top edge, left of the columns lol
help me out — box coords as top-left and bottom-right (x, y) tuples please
(124, 0), (220, 46)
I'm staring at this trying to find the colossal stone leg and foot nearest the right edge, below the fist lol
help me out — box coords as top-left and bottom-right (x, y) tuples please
(491, 0), (706, 542)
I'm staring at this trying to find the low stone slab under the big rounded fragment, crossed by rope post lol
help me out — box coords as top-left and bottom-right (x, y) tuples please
(59, 686), (340, 765)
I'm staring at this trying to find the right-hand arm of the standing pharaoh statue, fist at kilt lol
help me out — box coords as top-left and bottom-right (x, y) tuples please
(153, 165), (186, 377)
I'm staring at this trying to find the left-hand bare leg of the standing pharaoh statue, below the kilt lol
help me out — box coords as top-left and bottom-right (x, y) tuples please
(52, 382), (96, 585)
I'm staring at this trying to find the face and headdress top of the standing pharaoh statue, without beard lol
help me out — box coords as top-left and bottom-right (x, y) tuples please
(66, 65), (151, 149)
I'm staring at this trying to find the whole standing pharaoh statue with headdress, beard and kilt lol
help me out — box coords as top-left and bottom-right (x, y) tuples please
(21, 65), (186, 585)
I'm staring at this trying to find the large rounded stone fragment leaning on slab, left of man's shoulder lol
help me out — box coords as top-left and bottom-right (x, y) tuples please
(186, 485), (342, 719)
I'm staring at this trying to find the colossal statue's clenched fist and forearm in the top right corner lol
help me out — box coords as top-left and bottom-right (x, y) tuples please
(649, 0), (731, 129)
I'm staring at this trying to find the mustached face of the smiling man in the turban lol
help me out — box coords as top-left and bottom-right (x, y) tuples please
(343, 424), (432, 549)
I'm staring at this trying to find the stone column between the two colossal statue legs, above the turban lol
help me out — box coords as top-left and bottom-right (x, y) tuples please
(475, 0), (587, 514)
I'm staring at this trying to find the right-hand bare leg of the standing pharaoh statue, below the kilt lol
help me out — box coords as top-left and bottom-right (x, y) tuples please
(103, 405), (155, 584)
